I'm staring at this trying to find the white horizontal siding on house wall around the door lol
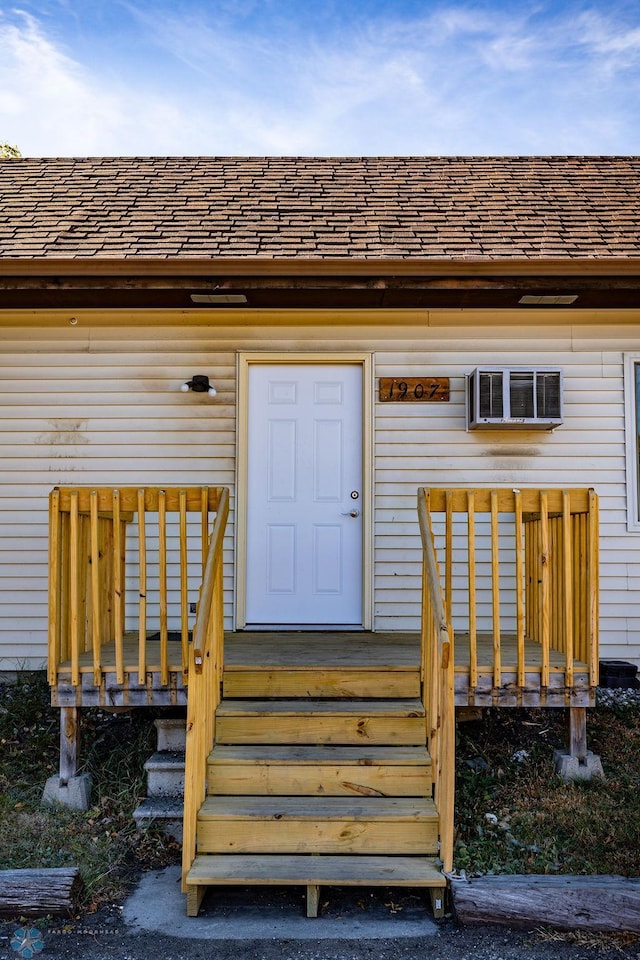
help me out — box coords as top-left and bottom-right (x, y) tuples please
(0, 311), (640, 669)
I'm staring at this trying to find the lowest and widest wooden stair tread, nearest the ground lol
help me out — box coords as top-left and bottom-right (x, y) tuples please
(187, 854), (446, 887)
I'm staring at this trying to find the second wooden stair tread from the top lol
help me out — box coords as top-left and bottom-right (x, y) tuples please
(209, 743), (431, 767)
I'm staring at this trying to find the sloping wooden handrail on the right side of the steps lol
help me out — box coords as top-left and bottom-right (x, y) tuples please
(418, 490), (455, 873)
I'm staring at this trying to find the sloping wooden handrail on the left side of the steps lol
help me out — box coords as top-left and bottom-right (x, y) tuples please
(182, 489), (229, 893)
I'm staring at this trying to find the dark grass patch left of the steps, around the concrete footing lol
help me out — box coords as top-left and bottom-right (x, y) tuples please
(0, 672), (178, 911)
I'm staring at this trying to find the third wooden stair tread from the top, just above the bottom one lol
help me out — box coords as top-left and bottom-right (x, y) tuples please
(198, 796), (437, 823)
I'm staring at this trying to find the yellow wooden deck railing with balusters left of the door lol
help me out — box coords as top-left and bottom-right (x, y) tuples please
(48, 487), (228, 686)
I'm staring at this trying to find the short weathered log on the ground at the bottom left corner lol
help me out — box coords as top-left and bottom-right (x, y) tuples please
(0, 867), (80, 918)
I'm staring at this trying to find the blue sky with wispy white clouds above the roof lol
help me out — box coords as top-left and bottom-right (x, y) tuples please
(0, 0), (640, 156)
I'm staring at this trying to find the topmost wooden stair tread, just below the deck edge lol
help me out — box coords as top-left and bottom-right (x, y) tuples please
(216, 699), (425, 718)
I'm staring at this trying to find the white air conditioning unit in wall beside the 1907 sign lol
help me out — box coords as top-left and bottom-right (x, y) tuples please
(467, 367), (562, 430)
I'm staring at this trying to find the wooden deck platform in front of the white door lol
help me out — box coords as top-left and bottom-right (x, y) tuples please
(52, 631), (593, 707)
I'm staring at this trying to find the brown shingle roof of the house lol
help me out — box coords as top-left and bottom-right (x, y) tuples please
(0, 157), (640, 260)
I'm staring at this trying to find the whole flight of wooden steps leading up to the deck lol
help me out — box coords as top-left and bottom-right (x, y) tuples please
(186, 667), (445, 916)
